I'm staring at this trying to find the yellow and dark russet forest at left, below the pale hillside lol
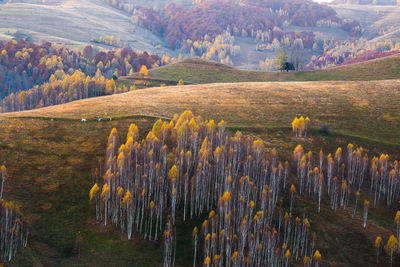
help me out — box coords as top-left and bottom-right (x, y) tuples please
(0, 40), (165, 112)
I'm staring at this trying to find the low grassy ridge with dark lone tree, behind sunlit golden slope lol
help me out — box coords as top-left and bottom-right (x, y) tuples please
(146, 55), (400, 83)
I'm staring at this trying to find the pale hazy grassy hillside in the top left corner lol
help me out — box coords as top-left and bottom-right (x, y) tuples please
(0, 0), (176, 56)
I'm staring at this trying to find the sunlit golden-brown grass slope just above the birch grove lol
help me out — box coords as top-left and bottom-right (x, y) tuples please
(0, 80), (400, 143)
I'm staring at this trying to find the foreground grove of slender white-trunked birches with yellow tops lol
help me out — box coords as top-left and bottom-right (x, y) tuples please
(89, 111), (400, 266)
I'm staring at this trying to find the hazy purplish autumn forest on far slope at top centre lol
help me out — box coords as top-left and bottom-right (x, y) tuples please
(106, 0), (362, 64)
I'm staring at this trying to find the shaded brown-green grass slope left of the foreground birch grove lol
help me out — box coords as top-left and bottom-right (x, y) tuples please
(0, 118), (162, 266)
